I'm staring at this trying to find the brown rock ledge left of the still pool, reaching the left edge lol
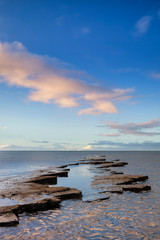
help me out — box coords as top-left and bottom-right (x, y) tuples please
(0, 168), (82, 226)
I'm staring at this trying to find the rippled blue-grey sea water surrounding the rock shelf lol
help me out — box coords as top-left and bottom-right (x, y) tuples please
(0, 151), (160, 240)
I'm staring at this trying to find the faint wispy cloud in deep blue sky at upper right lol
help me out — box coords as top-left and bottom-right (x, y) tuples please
(134, 16), (152, 36)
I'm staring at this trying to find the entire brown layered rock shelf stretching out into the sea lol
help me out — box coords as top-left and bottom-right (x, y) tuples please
(0, 156), (151, 227)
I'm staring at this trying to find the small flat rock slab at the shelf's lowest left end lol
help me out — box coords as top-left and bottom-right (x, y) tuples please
(0, 212), (19, 227)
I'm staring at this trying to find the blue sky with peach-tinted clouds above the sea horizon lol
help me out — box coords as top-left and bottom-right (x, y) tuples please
(0, 0), (160, 151)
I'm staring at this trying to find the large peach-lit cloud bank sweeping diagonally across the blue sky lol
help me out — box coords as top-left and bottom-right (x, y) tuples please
(0, 42), (134, 115)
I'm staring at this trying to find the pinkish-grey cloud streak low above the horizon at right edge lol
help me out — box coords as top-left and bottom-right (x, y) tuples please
(101, 119), (160, 136)
